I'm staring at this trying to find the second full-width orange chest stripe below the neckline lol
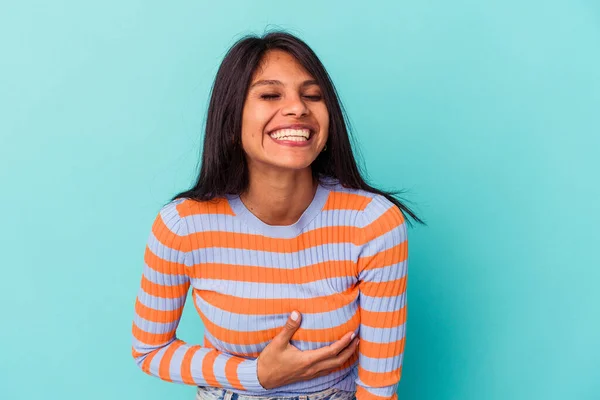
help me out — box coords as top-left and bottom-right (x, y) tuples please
(190, 260), (357, 284)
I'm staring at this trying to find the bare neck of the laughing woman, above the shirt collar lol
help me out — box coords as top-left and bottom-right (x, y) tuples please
(240, 168), (317, 225)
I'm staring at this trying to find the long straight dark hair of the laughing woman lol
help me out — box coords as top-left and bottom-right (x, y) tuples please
(172, 31), (424, 224)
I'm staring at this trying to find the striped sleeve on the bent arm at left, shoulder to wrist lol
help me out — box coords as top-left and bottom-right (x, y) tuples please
(132, 200), (267, 393)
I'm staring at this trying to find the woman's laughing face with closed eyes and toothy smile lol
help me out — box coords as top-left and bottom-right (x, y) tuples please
(242, 50), (329, 170)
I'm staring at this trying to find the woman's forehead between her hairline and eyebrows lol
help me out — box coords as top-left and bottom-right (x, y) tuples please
(252, 50), (313, 82)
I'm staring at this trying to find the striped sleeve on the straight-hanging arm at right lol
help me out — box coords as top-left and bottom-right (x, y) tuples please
(355, 197), (408, 400)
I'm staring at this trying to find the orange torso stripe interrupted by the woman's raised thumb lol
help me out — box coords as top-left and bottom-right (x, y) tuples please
(194, 303), (360, 345)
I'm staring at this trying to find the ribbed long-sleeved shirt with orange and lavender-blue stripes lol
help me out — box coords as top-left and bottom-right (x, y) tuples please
(132, 179), (408, 400)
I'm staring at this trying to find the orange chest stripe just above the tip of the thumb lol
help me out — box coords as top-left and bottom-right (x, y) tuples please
(194, 286), (359, 315)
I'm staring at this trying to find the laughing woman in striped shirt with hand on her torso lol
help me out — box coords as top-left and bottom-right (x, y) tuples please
(133, 28), (421, 400)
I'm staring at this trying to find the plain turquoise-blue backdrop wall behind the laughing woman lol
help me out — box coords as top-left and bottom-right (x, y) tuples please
(0, 0), (600, 400)
